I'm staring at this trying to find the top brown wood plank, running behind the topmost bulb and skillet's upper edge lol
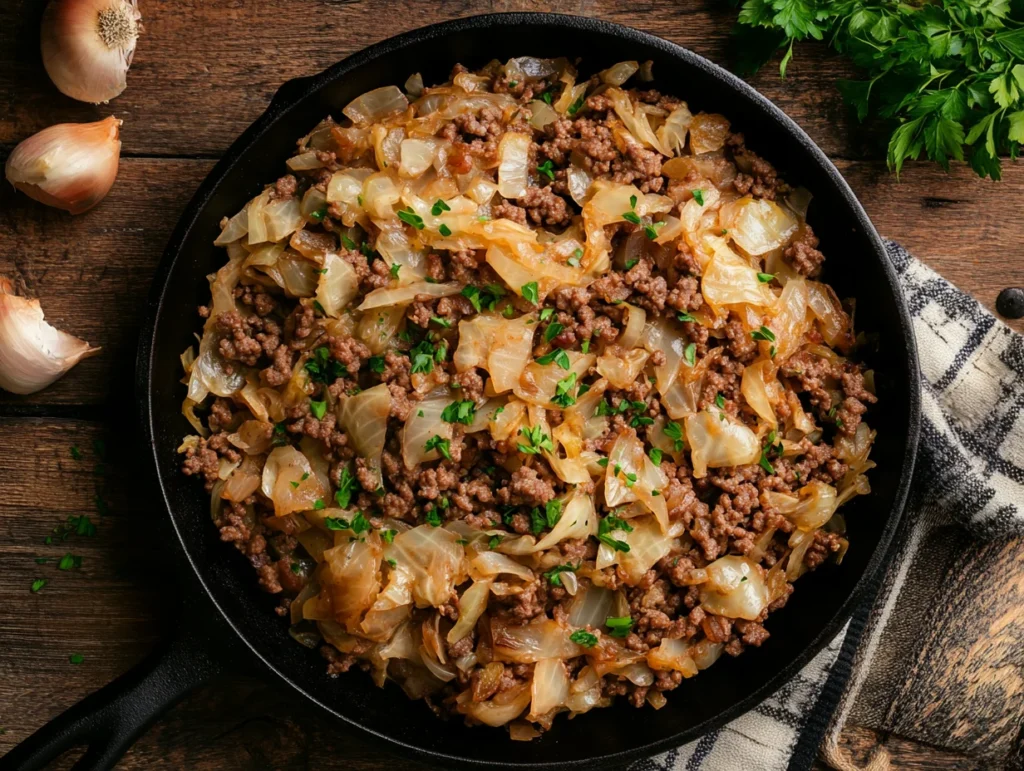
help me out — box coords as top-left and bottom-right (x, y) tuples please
(0, 0), (884, 158)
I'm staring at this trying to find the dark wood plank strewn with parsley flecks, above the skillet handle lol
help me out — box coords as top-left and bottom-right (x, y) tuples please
(0, 419), (165, 755)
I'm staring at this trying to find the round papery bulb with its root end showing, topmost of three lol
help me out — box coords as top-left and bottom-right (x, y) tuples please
(41, 0), (142, 104)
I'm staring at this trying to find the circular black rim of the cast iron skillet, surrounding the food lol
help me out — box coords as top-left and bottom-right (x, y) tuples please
(136, 11), (921, 769)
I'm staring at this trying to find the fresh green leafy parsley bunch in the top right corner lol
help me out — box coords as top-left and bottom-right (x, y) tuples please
(736, 0), (1024, 179)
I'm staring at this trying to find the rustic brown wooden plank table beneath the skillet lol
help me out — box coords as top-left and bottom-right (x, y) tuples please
(0, 0), (1024, 769)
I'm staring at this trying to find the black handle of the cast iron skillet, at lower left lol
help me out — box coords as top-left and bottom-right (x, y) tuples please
(0, 616), (222, 771)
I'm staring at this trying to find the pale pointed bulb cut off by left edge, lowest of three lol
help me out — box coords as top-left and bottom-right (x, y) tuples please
(0, 275), (99, 394)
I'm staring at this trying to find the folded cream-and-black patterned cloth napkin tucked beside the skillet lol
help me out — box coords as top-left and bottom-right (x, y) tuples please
(631, 242), (1024, 771)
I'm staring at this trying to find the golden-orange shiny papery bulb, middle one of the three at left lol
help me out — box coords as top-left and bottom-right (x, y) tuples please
(6, 116), (121, 214)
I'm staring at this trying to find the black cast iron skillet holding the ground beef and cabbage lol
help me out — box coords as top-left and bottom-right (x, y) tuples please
(0, 13), (920, 771)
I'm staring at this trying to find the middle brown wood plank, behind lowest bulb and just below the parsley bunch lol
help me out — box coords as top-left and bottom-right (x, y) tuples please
(0, 159), (1024, 405)
